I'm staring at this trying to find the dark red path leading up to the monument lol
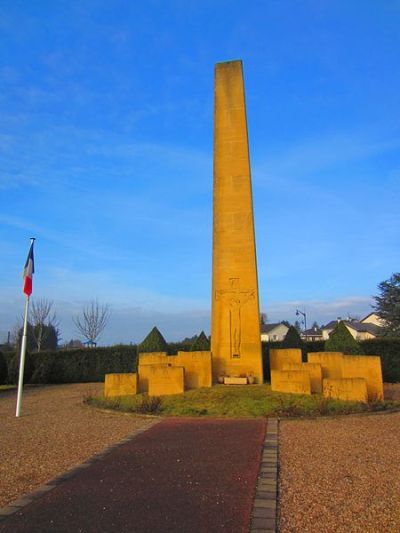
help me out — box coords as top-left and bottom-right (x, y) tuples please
(0, 418), (266, 533)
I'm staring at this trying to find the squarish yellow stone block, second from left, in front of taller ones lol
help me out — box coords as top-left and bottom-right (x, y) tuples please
(146, 363), (185, 396)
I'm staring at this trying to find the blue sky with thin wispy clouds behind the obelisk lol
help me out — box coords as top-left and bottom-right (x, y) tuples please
(0, 0), (400, 344)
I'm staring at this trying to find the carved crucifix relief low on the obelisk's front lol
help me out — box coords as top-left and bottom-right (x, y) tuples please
(215, 278), (255, 358)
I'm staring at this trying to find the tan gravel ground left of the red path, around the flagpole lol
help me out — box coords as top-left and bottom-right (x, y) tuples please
(0, 383), (155, 507)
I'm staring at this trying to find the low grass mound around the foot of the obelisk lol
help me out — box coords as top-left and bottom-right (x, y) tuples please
(86, 385), (400, 417)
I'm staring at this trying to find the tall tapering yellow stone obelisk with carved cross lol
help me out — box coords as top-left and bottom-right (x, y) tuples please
(211, 61), (263, 383)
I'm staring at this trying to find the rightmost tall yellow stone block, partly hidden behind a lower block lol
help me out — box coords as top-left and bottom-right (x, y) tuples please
(342, 355), (383, 400)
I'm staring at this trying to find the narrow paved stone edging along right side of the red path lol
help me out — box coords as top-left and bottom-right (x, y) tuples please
(250, 418), (279, 533)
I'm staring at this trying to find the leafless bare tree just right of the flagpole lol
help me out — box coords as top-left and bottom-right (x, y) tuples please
(29, 299), (60, 352)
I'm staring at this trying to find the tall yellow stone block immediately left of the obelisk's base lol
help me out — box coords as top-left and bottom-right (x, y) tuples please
(175, 351), (212, 389)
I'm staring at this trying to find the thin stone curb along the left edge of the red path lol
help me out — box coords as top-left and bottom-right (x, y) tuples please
(0, 422), (157, 522)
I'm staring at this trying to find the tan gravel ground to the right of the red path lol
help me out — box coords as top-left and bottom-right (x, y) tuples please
(279, 386), (400, 533)
